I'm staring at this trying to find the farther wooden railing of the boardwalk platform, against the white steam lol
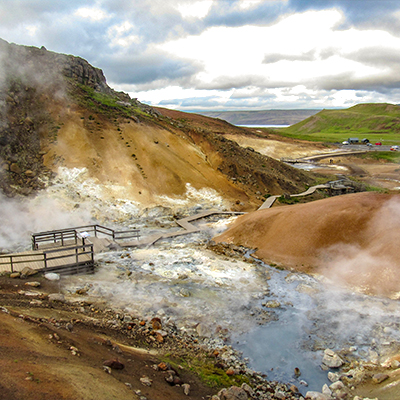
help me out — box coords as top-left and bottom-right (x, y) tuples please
(32, 225), (140, 250)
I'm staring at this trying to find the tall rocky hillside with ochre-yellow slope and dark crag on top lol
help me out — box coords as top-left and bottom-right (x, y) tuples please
(0, 41), (314, 209)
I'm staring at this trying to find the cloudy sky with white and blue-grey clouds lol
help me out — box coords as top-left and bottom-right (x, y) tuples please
(0, 0), (400, 110)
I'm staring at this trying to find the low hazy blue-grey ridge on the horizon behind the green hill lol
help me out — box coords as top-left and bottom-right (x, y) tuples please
(199, 110), (321, 125)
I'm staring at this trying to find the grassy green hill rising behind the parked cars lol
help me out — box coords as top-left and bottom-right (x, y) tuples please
(286, 103), (400, 135)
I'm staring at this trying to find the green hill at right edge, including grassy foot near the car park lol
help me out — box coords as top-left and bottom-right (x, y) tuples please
(282, 103), (400, 144)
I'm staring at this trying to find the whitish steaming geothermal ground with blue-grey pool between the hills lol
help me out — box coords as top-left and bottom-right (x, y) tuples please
(0, 169), (400, 392)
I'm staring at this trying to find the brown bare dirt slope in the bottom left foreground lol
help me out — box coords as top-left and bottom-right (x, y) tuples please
(0, 277), (216, 400)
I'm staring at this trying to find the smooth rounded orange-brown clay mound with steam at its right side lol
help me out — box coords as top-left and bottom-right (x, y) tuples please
(214, 192), (400, 298)
